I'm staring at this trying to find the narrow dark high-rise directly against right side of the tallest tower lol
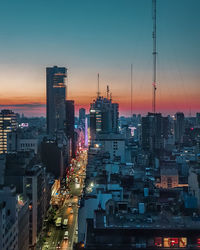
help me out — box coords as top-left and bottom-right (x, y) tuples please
(65, 100), (76, 157)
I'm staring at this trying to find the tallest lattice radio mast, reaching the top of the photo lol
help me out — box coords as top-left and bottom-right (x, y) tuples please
(152, 0), (157, 114)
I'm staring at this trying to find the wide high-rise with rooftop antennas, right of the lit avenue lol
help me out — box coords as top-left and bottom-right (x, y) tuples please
(90, 96), (119, 139)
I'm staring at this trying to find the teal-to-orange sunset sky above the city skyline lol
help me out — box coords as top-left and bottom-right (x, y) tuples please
(0, 0), (200, 116)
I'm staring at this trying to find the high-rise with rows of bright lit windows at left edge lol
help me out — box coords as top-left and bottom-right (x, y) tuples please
(0, 109), (17, 154)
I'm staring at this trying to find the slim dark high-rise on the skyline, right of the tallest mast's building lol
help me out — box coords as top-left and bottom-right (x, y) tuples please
(174, 112), (185, 143)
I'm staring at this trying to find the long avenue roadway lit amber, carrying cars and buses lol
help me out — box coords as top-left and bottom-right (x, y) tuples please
(37, 151), (87, 250)
